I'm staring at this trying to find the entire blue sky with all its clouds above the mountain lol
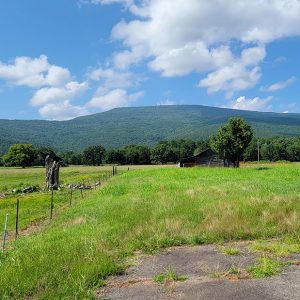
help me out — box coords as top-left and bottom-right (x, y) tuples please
(0, 0), (300, 120)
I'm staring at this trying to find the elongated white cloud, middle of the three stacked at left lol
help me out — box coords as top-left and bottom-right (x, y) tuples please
(30, 81), (88, 106)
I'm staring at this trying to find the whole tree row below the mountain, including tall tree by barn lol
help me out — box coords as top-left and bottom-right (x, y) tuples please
(0, 117), (300, 168)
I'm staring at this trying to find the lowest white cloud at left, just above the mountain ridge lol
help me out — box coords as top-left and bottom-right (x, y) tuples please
(39, 100), (89, 121)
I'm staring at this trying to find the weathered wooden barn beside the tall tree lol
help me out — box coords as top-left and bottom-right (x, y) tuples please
(178, 149), (232, 168)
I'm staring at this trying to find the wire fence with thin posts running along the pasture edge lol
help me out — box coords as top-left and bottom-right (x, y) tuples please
(2, 166), (129, 254)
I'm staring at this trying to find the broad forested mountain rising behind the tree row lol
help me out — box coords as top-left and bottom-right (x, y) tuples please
(0, 105), (300, 154)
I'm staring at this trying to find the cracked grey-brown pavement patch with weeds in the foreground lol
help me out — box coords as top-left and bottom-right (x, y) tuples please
(96, 242), (300, 300)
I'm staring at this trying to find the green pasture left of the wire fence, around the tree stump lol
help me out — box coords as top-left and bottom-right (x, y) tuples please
(0, 166), (119, 233)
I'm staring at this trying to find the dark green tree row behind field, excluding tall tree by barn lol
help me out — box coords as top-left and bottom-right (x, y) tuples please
(0, 137), (300, 167)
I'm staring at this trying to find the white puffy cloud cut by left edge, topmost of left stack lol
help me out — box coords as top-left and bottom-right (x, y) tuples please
(0, 55), (71, 88)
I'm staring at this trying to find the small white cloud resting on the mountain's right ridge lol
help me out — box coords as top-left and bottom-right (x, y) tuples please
(225, 96), (272, 111)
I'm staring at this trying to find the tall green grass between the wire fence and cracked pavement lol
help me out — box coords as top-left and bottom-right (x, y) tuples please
(0, 164), (300, 299)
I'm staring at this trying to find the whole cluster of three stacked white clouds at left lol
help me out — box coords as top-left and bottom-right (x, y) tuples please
(0, 55), (92, 120)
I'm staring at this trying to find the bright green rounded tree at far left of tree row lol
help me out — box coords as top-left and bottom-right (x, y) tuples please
(3, 144), (36, 168)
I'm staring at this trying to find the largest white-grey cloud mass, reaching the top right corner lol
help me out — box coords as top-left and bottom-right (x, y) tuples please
(92, 0), (300, 95)
